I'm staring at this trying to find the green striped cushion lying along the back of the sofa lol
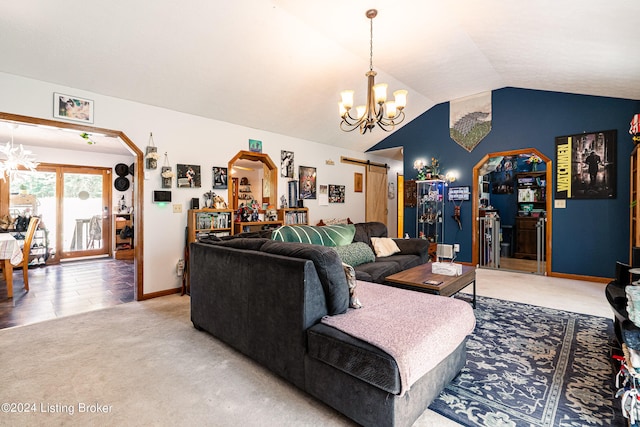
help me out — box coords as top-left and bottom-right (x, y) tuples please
(271, 224), (356, 246)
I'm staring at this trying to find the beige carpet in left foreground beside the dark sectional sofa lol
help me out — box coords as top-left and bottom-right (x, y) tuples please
(0, 295), (456, 426)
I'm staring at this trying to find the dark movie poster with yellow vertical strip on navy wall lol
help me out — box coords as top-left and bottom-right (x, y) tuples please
(554, 129), (617, 199)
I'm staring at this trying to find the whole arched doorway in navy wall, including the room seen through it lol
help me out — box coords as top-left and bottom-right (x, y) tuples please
(472, 149), (552, 275)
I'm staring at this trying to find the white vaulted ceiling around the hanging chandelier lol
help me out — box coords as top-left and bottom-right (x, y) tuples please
(0, 0), (640, 156)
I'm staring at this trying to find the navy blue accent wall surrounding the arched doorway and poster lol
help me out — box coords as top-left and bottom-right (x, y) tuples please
(369, 88), (640, 277)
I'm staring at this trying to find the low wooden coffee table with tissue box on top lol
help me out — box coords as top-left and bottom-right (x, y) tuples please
(385, 262), (476, 308)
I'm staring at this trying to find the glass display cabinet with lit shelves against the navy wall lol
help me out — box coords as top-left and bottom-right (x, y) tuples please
(416, 179), (447, 244)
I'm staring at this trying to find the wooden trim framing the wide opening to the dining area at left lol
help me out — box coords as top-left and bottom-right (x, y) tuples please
(0, 112), (145, 301)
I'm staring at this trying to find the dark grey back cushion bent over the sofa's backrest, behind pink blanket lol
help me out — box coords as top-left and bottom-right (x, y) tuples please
(260, 240), (349, 315)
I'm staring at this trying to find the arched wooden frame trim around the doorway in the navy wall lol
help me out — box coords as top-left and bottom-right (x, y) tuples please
(472, 148), (553, 275)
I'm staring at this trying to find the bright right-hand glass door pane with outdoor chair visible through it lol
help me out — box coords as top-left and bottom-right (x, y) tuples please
(62, 170), (109, 258)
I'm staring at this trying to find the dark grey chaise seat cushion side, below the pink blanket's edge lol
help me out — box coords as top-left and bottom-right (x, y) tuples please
(307, 323), (401, 394)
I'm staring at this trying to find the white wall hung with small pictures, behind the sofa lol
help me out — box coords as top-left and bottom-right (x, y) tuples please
(0, 73), (402, 294)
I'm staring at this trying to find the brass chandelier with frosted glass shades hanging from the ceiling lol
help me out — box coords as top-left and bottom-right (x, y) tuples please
(338, 9), (407, 135)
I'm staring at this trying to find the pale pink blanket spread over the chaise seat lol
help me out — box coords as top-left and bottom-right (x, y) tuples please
(322, 281), (476, 395)
